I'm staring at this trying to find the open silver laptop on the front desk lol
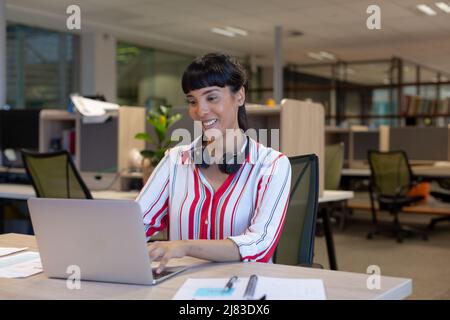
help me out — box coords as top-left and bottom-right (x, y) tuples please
(28, 198), (187, 285)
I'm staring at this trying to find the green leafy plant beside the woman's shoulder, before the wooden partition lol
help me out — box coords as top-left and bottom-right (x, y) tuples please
(135, 105), (182, 184)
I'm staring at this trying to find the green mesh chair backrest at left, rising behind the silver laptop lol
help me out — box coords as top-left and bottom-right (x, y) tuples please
(21, 150), (92, 199)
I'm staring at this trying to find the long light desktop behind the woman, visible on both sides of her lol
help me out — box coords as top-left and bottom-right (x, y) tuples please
(0, 183), (354, 203)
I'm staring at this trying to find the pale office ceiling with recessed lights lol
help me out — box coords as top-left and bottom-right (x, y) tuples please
(6, 0), (450, 73)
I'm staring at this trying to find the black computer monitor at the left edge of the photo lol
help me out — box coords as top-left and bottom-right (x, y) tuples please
(0, 109), (40, 167)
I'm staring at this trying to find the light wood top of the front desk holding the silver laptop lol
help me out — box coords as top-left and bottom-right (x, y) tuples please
(0, 234), (412, 300)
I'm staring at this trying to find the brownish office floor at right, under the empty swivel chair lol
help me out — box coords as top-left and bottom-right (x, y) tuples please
(315, 211), (450, 299)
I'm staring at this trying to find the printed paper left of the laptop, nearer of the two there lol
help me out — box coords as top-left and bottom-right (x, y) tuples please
(0, 251), (43, 278)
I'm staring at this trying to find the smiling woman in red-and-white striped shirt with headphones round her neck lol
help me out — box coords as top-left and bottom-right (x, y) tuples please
(136, 54), (291, 273)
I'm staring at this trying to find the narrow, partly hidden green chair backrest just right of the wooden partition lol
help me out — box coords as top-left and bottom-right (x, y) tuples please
(325, 142), (344, 190)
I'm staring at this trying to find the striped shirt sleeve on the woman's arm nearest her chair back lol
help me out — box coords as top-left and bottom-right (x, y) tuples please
(228, 154), (291, 262)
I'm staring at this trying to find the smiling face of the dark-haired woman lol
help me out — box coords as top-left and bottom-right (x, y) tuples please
(186, 86), (245, 136)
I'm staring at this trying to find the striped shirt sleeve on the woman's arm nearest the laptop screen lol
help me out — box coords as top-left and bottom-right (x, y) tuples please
(135, 152), (170, 240)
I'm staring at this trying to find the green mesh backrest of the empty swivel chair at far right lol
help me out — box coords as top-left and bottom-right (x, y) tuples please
(368, 150), (412, 196)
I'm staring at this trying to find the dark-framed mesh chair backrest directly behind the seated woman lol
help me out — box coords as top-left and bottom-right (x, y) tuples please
(274, 154), (319, 265)
